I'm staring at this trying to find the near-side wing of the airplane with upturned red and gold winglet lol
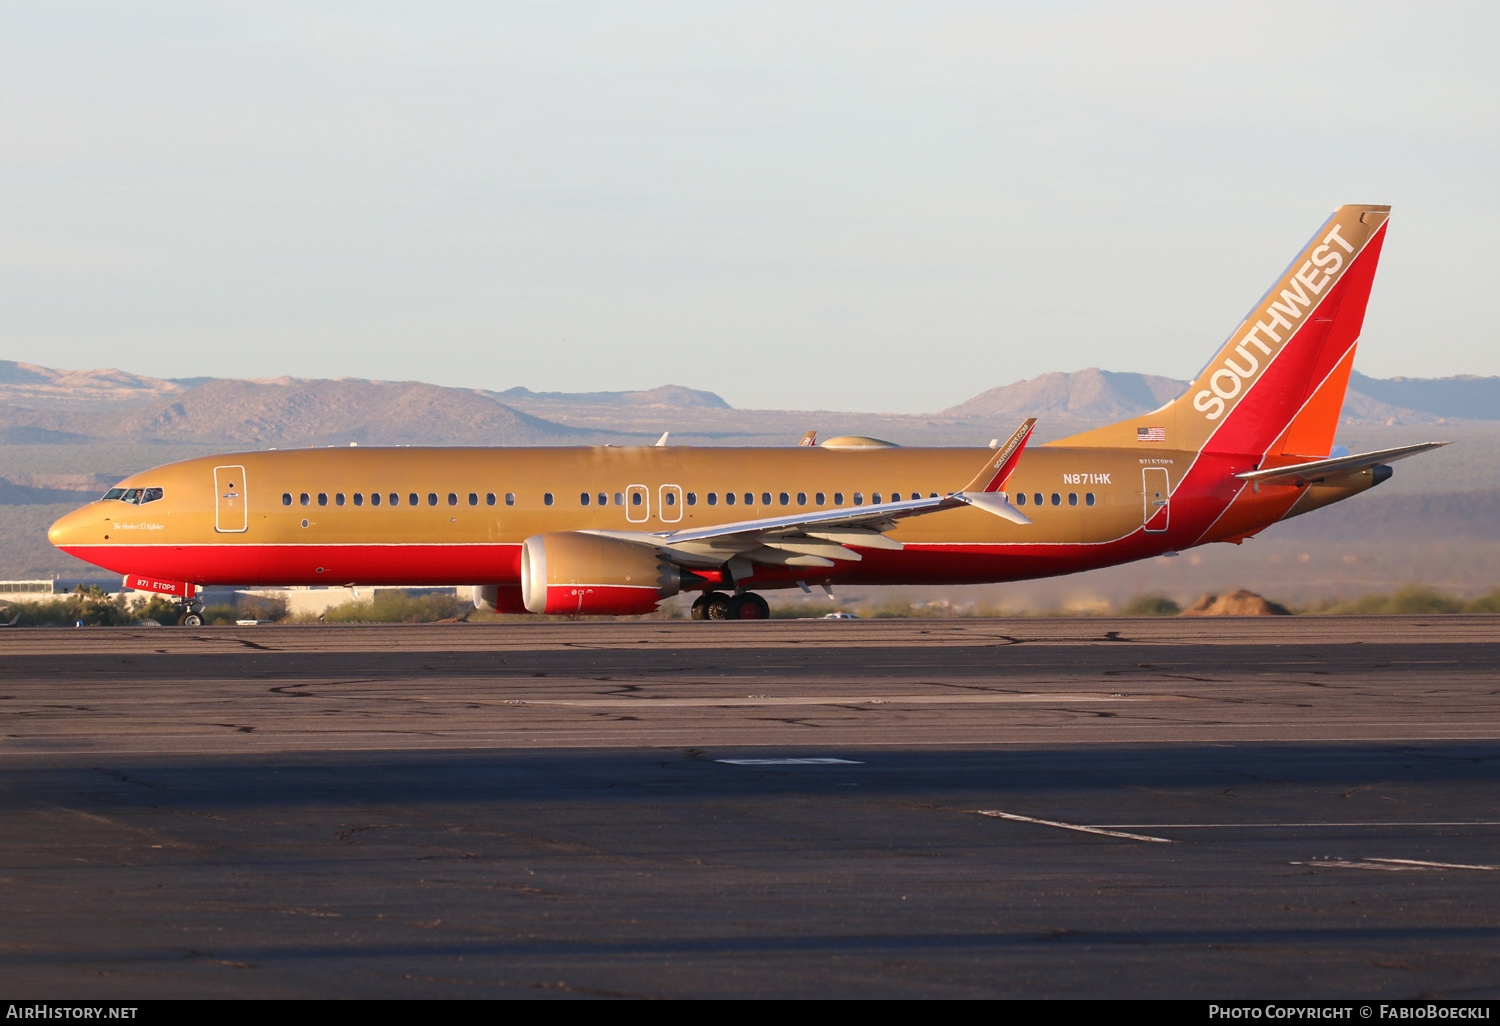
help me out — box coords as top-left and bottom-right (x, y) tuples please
(585, 419), (1037, 567)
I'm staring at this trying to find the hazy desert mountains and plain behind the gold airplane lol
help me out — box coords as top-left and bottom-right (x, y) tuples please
(0, 362), (1500, 588)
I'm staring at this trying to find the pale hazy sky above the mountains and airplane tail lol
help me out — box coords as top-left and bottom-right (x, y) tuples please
(0, 0), (1500, 413)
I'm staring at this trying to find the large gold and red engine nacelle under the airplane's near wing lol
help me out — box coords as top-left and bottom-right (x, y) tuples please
(521, 531), (684, 617)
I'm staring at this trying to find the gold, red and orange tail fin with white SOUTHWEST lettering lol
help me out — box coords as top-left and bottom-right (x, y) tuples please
(1053, 204), (1391, 456)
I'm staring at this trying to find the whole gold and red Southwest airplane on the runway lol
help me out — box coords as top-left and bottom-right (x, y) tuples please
(48, 204), (1443, 624)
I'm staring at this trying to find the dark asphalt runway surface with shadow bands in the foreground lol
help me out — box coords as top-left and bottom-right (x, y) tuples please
(0, 617), (1500, 998)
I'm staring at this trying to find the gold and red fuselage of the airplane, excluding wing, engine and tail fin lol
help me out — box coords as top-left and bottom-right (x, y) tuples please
(50, 446), (1368, 587)
